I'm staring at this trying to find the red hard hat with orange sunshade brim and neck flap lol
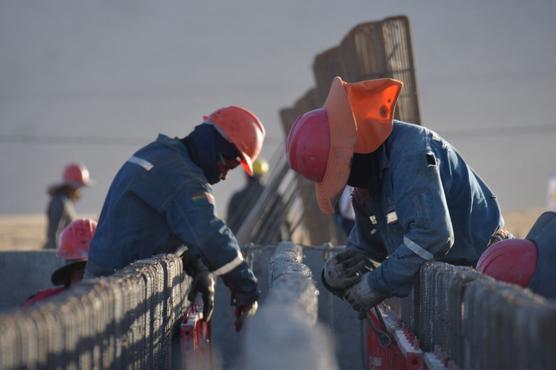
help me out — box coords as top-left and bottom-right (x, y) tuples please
(286, 77), (403, 214)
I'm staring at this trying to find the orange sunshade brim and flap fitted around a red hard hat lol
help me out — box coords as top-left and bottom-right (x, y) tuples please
(315, 77), (403, 214)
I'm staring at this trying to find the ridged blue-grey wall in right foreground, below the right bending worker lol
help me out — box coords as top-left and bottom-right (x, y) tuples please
(401, 262), (556, 370)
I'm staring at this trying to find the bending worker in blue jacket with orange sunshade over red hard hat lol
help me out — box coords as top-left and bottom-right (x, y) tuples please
(286, 77), (510, 317)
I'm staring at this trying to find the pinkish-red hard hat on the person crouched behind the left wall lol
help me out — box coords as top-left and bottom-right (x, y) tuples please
(57, 218), (97, 261)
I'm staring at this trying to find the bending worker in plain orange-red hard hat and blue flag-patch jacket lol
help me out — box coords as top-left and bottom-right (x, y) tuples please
(86, 106), (265, 321)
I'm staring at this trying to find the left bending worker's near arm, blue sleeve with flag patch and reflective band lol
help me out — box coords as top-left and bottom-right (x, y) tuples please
(164, 182), (258, 301)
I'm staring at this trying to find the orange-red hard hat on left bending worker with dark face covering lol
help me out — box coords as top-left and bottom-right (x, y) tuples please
(207, 105), (265, 175)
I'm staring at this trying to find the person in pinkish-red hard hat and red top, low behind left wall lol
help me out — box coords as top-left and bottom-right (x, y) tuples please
(23, 219), (97, 307)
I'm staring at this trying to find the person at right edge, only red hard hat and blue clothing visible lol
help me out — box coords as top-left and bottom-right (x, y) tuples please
(477, 212), (556, 299)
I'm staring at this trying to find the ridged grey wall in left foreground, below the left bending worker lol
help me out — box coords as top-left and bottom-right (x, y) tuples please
(0, 255), (190, 369)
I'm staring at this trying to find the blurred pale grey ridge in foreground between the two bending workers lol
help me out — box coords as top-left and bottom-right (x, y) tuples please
(241, 243), (338, 370)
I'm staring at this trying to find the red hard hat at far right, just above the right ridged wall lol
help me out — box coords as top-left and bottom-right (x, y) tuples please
(476, 239), (538, 287)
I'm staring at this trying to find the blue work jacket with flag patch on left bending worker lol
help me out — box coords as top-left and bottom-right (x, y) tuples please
(87, 135), (257, 294)
